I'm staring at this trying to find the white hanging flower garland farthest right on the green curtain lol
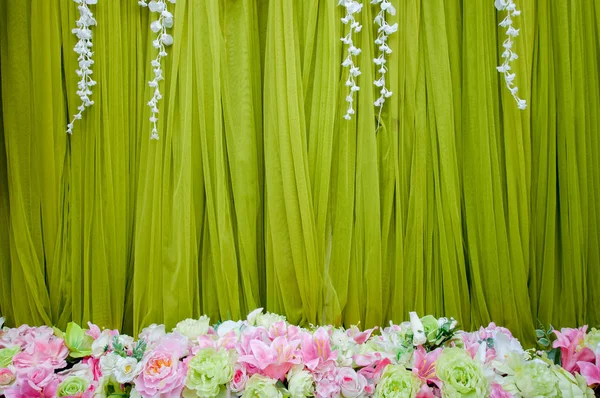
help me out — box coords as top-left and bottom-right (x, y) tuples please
(495, 0), (527, 110)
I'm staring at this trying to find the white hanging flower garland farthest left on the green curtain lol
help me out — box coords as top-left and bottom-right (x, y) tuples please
(67, 0), (98, 134)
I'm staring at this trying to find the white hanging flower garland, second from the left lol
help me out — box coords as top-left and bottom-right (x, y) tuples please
(138, 0), (176, 140)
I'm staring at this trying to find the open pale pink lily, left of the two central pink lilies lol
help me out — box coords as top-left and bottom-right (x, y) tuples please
(239, 337), (301, 380)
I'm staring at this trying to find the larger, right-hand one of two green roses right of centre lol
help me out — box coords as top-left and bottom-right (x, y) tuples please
(436, 347), (489, 398)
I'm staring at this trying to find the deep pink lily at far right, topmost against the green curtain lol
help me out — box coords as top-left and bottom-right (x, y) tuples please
(552, 326), (594, 373)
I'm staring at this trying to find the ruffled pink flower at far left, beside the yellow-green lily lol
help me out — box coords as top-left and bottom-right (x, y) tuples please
(13, 329), (69, 369)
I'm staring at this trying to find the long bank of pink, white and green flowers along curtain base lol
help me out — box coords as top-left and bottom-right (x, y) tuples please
(0, 309), (600, 398)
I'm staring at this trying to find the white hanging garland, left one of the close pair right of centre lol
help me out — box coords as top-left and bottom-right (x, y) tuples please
(338, 0), (363, 120)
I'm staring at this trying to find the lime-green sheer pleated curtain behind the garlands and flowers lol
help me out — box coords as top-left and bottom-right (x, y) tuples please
(0, 0), (600, 343)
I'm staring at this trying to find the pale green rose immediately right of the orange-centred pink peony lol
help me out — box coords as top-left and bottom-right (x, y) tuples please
(185, 347), (233, 397)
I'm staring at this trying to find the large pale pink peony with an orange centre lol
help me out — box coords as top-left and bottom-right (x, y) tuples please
(135, 333), (188, 398)
